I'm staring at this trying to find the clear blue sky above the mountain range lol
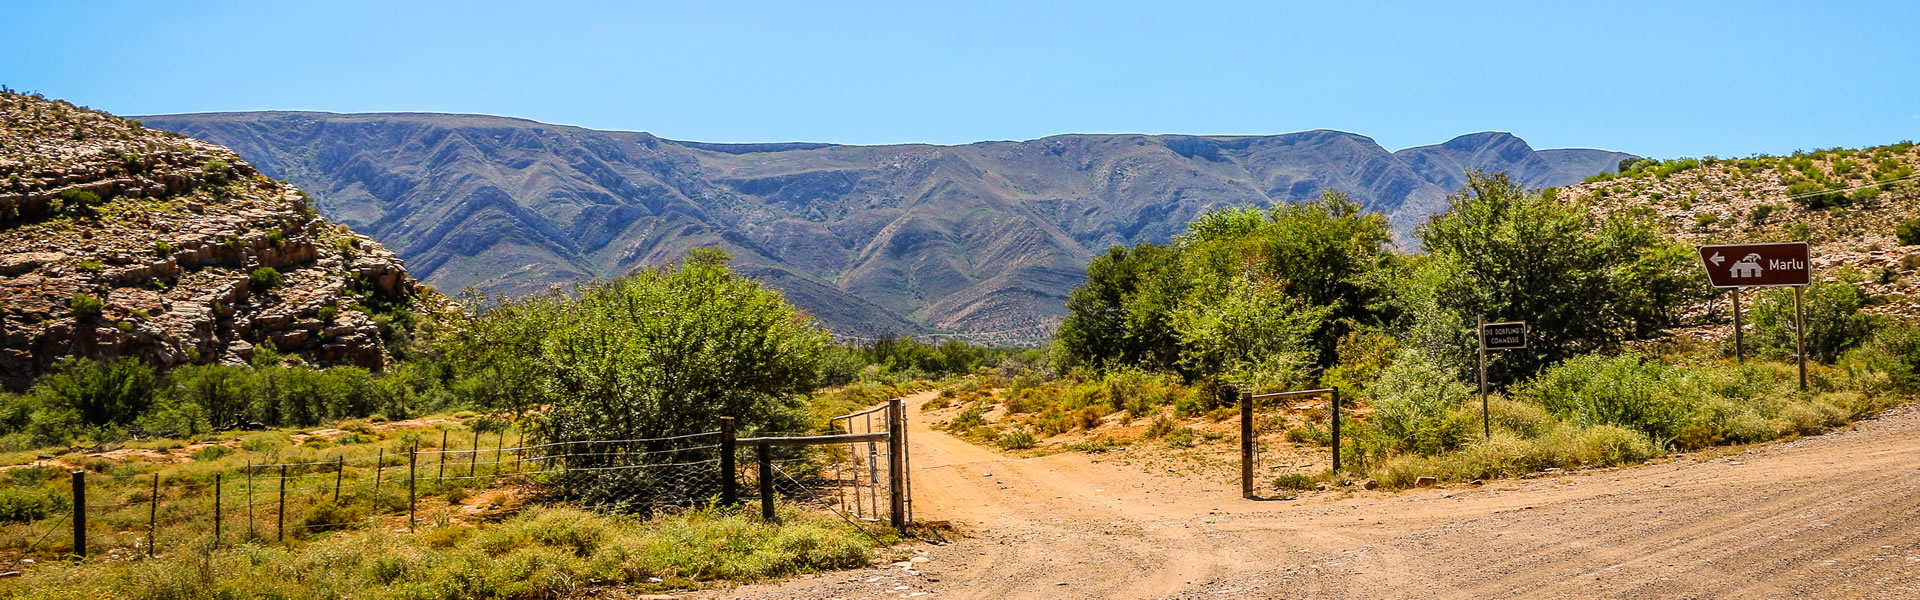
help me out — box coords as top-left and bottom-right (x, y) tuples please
(0, 0), (1920, 158)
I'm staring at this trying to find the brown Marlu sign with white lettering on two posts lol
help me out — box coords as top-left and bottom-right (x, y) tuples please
(1699, 242), (1812, 390)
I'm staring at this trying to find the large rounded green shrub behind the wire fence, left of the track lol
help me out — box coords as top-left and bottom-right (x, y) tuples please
(453, 250), (828, 506)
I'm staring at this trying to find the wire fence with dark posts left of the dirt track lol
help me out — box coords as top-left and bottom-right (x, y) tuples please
(0, 405), (904, 558)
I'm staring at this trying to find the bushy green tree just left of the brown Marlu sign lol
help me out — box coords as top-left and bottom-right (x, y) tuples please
(1419, 171), (1705, 381)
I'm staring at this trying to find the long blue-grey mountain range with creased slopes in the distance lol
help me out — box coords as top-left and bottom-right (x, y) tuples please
(142, 112), (1626, 342)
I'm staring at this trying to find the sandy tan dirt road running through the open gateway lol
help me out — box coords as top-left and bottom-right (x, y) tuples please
(712, 398), (1920, 600)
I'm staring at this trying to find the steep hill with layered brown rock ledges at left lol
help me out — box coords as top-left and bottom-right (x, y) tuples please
(0, 92), (432, 388)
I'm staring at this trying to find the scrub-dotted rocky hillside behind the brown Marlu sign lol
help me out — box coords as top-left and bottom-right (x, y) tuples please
(1559, 142), (1920, 323)
